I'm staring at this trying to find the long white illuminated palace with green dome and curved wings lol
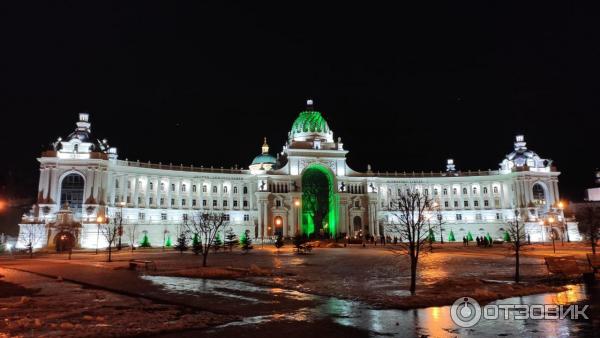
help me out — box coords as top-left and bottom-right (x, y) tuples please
(21, 100), (579, 248)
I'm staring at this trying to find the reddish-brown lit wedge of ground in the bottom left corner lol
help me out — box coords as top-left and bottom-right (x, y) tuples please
(0, 268), (235, 337)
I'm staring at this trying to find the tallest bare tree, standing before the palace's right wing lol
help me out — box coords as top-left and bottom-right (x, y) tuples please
(386, 189), (435, 295)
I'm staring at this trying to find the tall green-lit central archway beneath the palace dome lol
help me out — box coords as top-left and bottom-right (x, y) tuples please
(302, 163), (338, 237)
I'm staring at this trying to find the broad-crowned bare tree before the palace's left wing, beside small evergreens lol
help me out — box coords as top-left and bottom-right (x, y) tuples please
(185, 212), (228, 266)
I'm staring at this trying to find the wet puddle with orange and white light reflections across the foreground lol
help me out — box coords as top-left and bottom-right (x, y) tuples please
(143, 276), (599, 337)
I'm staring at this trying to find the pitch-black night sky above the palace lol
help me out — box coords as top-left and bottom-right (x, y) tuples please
(0, 1), (600, 199)
